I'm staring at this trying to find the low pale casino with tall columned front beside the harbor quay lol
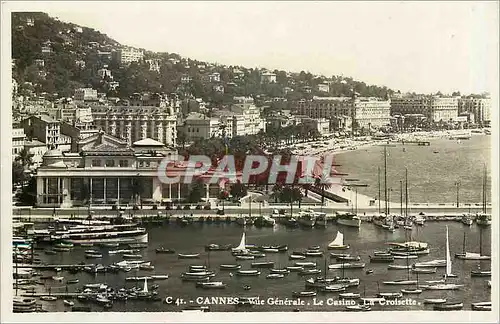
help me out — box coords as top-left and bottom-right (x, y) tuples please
(36, 133), (233, 207)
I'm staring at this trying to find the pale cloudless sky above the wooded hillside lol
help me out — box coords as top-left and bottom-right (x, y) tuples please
(4, 1), (498, 94)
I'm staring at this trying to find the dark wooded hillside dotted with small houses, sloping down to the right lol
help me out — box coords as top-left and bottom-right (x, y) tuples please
(12, 12), (393, 108)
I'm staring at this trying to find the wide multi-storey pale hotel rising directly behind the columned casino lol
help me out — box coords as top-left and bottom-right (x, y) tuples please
(92, 106), (177, 147)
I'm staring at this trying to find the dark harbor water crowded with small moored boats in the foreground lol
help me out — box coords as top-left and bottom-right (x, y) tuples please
(14, 216), (491, 312)
